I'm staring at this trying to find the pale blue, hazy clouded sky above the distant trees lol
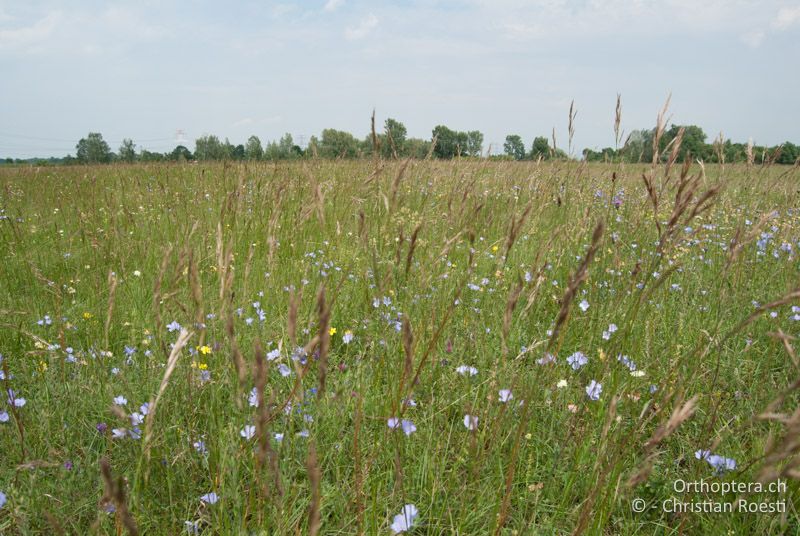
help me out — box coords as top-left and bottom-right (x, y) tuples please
(0, 0), (800, 158)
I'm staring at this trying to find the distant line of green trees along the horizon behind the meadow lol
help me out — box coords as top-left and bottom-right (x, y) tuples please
(5, 118), (800, 164)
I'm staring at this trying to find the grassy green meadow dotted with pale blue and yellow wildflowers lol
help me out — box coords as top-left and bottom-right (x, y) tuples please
(0, 153), (800, 535)
